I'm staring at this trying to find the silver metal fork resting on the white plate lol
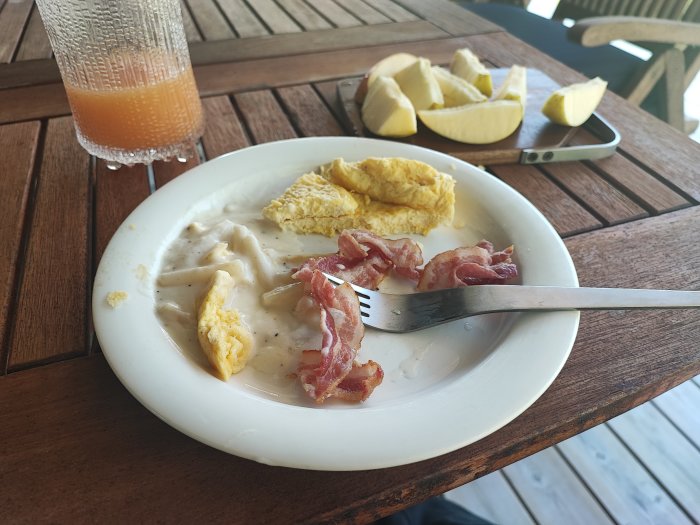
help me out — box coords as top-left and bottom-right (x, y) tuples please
(324, 273), (700, 332)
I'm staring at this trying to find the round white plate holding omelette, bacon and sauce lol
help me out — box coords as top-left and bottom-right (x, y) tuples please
(93, 137), (579, 470)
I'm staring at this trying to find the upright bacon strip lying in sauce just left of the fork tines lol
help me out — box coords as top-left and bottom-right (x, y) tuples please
(298, 270), (370, 403)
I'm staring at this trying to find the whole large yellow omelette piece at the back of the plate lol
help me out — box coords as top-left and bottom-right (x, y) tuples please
(263, 158), (455, 236)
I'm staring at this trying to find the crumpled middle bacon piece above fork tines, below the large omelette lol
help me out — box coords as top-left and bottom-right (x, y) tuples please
(292, 230), (423, 289)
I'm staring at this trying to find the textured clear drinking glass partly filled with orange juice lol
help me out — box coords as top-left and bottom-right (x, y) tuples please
(37, 0), (203, 164)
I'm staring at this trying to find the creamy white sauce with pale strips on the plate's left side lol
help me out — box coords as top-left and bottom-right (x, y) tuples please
(155, 214), (332, 395)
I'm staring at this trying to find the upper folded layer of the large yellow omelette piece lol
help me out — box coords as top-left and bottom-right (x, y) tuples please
(322, 157), (455, 224)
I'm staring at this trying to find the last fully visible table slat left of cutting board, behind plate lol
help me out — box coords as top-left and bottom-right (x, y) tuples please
(277, 84), (343, 137)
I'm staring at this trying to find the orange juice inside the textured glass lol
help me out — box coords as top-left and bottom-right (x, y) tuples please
(65, 68), (203, 150)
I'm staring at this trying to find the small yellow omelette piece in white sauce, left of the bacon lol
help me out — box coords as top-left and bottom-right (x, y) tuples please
(197, 270), (253, 381)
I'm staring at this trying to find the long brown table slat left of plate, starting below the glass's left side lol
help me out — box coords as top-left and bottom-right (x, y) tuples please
(9, 117), (92, 369)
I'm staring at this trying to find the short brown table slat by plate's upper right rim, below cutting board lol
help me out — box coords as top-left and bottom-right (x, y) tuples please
(491, 165), (602, 237)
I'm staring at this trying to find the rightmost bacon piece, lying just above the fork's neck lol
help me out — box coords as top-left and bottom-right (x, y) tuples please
(417, 241), (518, 291)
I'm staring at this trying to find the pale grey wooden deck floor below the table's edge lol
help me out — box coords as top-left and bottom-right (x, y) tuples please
(447, 376), (700, 525)
